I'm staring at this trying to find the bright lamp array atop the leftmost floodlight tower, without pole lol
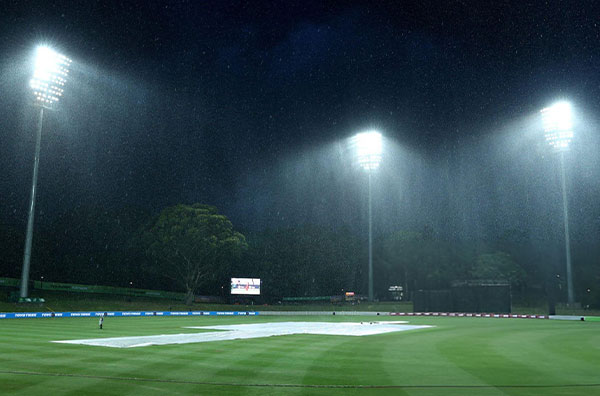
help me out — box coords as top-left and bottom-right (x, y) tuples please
(29, 47), (72, 107)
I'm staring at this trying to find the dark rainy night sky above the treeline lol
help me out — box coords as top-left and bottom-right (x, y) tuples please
(0, 0), (600, 248)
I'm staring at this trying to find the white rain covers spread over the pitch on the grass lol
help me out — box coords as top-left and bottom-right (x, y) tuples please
(52, 321), (432, 348)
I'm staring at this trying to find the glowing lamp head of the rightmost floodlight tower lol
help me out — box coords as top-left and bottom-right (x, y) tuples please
(541, 102), (573, 151)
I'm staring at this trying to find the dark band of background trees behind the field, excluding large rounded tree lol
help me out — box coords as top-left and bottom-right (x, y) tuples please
(0, 203), (600, 307)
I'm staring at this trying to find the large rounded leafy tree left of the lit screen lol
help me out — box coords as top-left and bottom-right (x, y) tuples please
(144, 204), (247, 304)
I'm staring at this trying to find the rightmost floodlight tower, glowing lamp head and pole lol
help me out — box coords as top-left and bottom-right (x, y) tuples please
(541, 102), (575, 304)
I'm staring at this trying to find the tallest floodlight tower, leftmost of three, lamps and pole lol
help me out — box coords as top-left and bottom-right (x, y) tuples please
(20, 46), (71, 298)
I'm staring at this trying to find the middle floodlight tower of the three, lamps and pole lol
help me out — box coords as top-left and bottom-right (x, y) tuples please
(350, 131), (383, 301)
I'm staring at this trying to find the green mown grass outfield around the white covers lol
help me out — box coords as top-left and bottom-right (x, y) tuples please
(0, 316), (600, 396)
